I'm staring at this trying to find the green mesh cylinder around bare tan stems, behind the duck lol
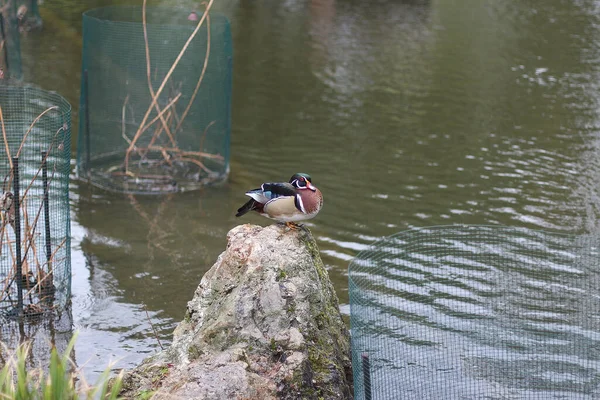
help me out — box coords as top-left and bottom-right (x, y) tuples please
(77, 6), (232, 193)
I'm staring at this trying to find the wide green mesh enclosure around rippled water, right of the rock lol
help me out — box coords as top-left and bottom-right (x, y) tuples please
(349, 226), (600, 400)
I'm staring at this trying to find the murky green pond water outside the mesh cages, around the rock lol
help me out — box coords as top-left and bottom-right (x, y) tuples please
(10, 0), (600, 388)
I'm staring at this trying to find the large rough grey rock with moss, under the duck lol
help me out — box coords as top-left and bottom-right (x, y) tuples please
(121, 225), (352, 400)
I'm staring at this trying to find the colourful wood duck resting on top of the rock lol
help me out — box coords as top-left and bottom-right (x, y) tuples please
(235, 173), (323, 229)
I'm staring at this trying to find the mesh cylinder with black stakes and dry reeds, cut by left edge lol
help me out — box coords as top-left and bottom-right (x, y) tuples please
(0, 85), (71, 324)
